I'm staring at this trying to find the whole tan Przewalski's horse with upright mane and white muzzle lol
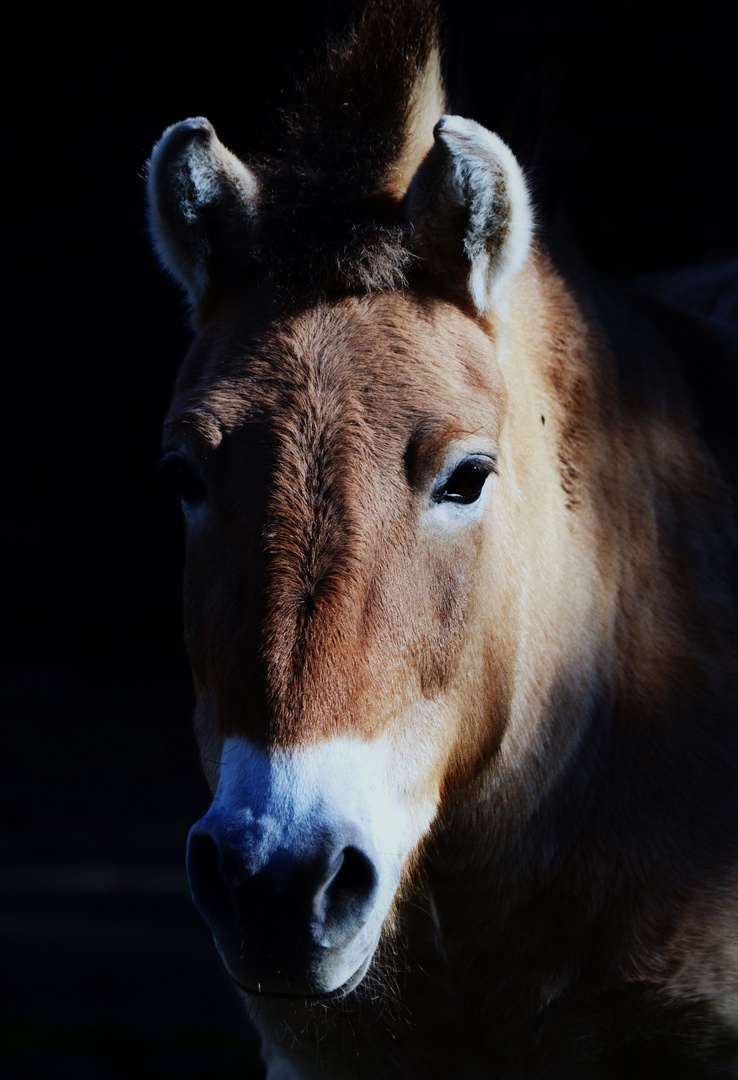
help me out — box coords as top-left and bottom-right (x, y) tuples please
(149, 2), (738, 1080)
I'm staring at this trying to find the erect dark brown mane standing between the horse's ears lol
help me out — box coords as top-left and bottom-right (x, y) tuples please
(250, 0), (443, 299)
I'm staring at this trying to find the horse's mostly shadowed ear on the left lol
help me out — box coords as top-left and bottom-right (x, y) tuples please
(148, 117), (258, 303)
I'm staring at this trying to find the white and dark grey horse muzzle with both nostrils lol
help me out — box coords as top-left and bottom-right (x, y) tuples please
(187, 743), (401, 998)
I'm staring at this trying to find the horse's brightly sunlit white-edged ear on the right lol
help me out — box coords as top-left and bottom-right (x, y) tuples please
(408, 117), (533, 314)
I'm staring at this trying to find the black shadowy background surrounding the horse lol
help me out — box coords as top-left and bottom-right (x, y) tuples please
(0, 0), (738, 1080)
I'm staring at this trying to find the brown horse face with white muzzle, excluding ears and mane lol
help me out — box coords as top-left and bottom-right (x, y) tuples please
(165, 293), (510, 996)
